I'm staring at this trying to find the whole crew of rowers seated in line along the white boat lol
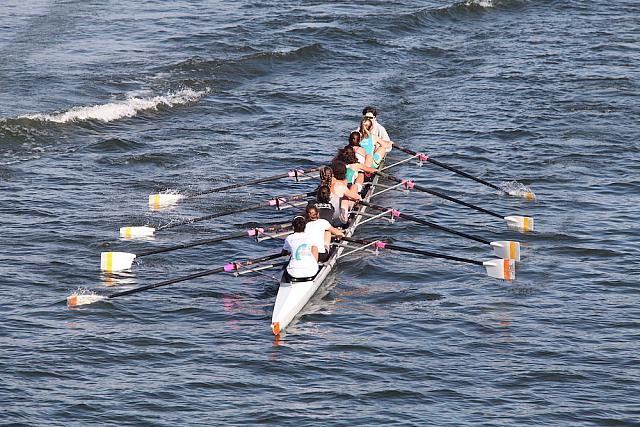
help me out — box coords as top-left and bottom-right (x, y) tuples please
(282, 106), (393, 279)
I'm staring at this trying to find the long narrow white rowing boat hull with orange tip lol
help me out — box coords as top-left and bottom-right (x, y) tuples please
(271, 169), (381, 335)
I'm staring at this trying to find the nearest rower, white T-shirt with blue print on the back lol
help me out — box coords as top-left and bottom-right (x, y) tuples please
(282, 215), (318, 279)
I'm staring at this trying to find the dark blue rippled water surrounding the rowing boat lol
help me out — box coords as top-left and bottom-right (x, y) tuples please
(0, 0), (640, 426)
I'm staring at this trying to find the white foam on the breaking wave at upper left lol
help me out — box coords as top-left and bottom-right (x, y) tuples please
(20, 89), (206, 123)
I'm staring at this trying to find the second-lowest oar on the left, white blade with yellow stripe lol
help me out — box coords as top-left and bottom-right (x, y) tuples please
(100, 221), (291, 272)
